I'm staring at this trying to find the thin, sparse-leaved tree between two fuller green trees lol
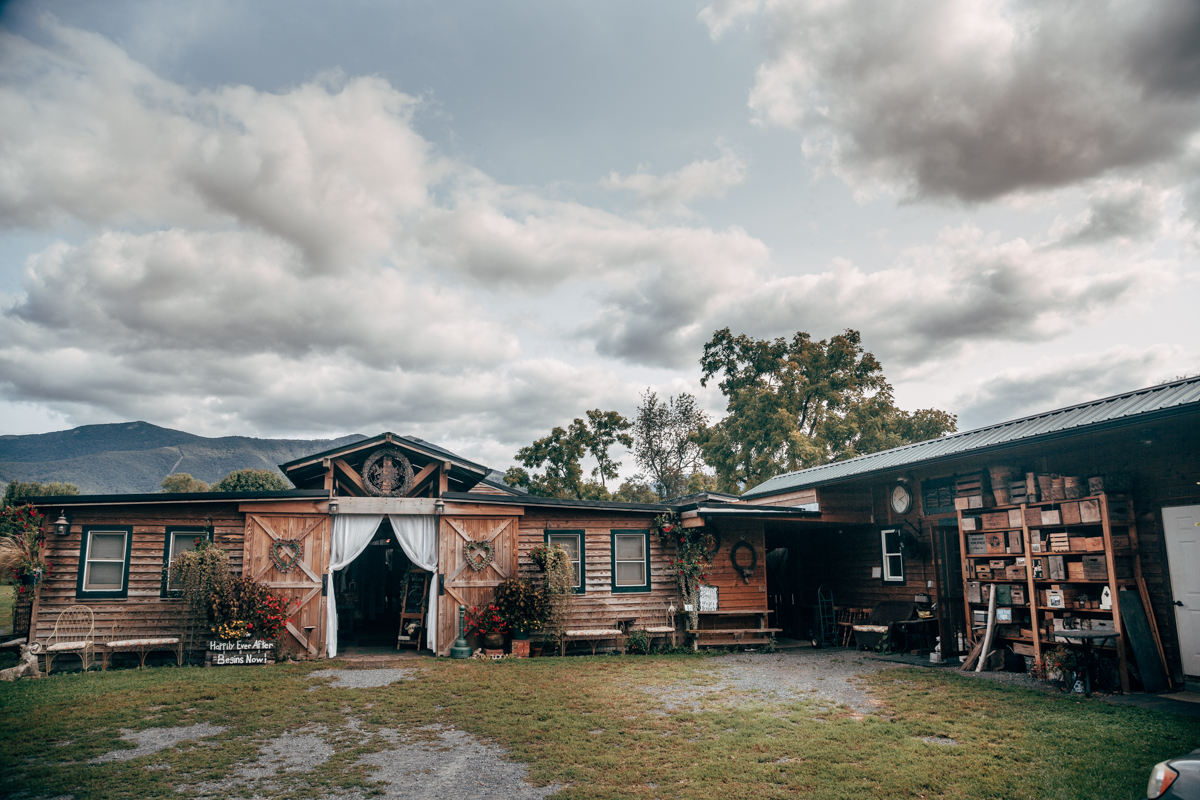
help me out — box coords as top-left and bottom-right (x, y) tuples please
(634, 389), (708, 498)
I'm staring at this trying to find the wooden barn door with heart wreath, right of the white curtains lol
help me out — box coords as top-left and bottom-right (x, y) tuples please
(438, 517), (517, 655)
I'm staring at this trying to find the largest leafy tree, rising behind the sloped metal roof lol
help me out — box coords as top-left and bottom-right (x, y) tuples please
(696, 327), (956, 492)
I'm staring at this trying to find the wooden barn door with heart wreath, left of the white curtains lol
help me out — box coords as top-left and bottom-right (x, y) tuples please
(242, 513), (330, 657)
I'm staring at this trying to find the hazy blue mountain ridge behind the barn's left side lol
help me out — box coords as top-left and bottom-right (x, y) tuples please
(0, 421), (367, 494)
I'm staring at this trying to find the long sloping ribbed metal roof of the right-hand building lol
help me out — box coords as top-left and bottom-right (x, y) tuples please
(742, 378), (1200, 498)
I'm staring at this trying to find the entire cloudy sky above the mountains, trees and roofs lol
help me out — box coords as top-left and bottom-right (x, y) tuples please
(0, 0), (1200, 471)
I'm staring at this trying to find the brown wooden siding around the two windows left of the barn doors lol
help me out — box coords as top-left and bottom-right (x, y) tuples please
(31, 503), (245, 666)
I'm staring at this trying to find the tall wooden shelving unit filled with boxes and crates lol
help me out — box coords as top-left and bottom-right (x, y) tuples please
(958, 494), (1158, 692)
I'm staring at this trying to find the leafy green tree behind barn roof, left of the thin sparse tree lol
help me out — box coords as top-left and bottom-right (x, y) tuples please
(504, 409), (634, 500)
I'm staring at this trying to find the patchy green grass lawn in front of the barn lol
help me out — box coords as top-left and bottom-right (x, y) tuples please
(0, 656), (1200, 800)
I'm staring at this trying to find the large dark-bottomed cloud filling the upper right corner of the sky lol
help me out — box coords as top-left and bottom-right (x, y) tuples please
(714, 0), (1200, 200)
